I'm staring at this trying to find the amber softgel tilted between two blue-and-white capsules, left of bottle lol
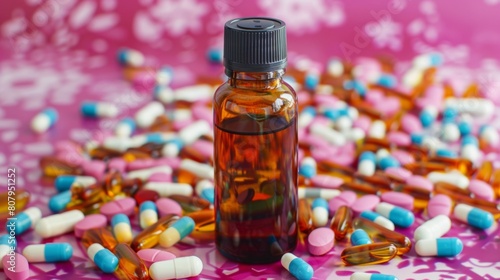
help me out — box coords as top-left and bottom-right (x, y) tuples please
(131, 214), (179, 252)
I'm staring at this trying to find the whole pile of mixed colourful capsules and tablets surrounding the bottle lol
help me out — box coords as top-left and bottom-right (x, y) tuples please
(0, 49), (500, 280)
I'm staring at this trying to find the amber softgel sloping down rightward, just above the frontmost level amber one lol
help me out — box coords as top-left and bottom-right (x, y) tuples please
(352, 218), (411, 255)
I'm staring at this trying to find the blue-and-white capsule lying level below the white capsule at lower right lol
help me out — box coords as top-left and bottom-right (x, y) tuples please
(415, 237), (464, 257)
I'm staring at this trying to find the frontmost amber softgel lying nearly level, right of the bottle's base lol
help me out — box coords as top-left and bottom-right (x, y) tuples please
(340, 242), (398, 265)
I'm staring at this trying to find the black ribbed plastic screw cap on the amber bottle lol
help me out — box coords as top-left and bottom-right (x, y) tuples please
(224, 17), (286, 75)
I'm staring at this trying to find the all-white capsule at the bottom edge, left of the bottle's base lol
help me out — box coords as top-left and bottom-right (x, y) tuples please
(149, 256), (203, 280)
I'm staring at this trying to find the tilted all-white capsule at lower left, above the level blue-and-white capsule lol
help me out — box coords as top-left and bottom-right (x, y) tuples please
(35, 210), (85, 238)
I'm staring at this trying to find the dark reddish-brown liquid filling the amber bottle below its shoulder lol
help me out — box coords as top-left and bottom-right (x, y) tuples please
(214, 114), (297, 263)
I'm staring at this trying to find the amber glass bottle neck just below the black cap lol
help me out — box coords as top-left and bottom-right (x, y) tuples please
(226, 69), (285, 90)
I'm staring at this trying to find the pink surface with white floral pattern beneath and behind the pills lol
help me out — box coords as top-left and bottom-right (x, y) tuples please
(0, 0), (500, 279)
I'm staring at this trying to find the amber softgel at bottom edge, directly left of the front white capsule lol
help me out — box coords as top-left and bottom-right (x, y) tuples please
(113, 243), (150, 280)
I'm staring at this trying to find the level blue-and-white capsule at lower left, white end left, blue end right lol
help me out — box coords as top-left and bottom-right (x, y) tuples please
(23, 243), (73, 263)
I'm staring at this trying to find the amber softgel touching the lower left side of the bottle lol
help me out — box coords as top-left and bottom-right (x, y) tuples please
(186, 209), (215, 243)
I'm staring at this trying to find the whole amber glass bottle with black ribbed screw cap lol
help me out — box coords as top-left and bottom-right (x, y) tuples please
(213, 18), (298, 263)
